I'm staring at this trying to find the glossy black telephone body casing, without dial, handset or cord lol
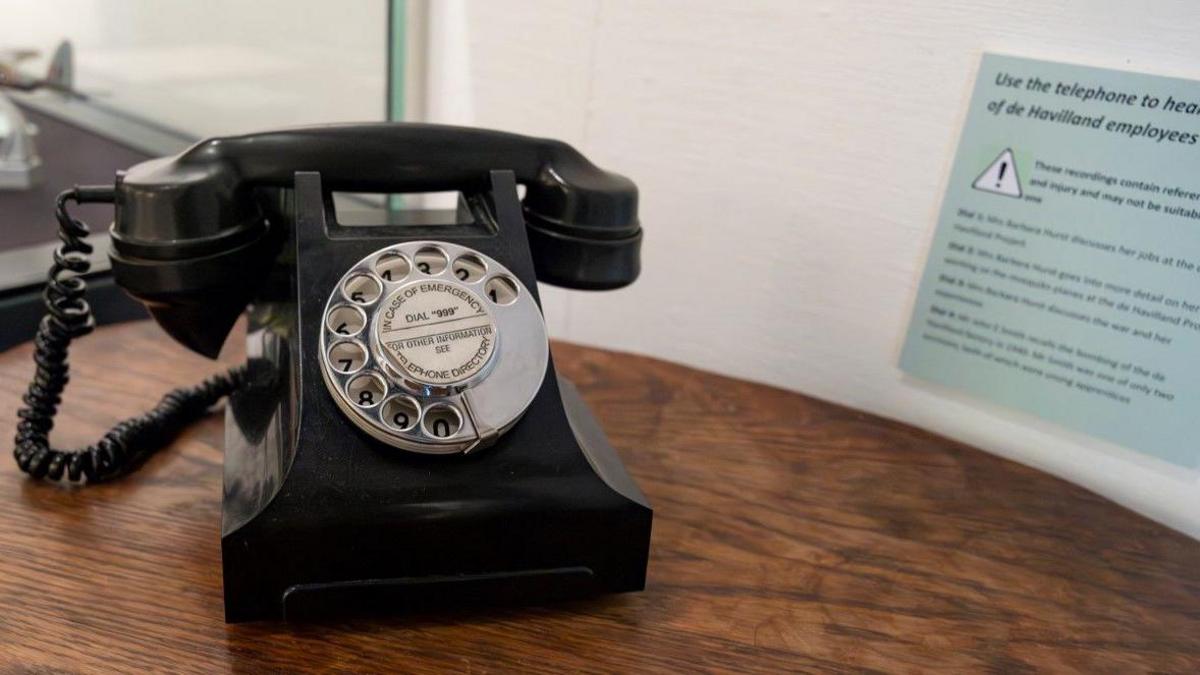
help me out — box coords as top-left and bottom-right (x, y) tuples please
(221, 172), (652, 621)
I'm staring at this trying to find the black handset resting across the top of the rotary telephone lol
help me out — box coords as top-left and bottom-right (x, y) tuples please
(110, 123), (642, 357)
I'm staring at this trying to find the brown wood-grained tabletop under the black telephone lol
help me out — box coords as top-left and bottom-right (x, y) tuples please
(0, 322), (1200, 673)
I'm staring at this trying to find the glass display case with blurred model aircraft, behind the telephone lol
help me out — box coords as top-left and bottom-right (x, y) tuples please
(0, 0), (392, 278)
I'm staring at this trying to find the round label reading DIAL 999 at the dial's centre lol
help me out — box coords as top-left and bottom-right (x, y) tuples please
(376, 281), (497, 387)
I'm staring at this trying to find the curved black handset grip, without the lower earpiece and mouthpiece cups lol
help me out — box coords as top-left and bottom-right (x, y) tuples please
(114, 123), (640, 243)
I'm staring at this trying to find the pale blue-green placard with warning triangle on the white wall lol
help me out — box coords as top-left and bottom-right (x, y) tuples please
(900, 54), (1200, 468)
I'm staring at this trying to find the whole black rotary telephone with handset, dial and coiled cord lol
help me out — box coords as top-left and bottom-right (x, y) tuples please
(14, 124), (652, 621)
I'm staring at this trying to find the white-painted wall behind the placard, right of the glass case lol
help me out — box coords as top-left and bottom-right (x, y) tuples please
(415, 0), (1200, 536)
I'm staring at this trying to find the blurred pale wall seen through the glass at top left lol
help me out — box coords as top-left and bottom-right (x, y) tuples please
(0, 0), (388, 137)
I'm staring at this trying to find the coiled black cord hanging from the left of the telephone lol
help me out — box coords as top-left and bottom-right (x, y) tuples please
(12, 186), (246, 483)
